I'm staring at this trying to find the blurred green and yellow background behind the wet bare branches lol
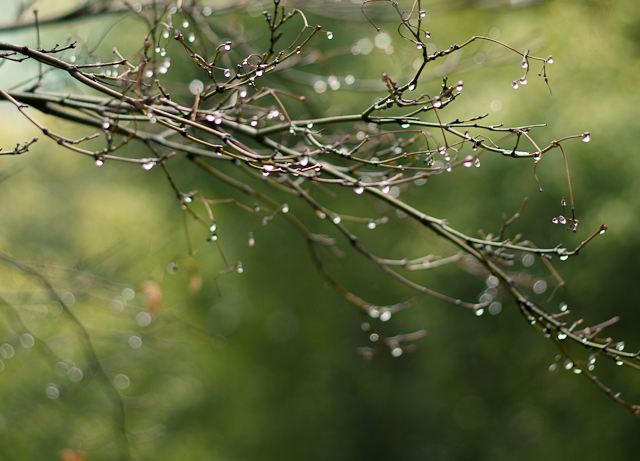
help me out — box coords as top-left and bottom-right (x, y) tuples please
(0, 0), (640, 461)
